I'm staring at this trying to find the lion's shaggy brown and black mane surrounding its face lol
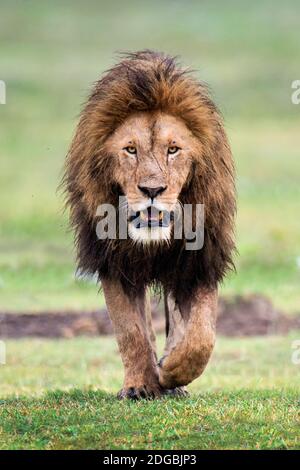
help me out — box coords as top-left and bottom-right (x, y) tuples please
(63, 50), (235, 300)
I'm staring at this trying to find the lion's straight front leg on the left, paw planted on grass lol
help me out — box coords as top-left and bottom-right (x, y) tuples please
(102, 280), (161, 399)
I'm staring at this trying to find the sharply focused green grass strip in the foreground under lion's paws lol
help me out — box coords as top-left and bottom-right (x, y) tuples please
(0, 390), (299, 450)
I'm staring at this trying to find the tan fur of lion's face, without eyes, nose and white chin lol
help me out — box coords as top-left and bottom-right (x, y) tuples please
(104, 112), (197, 217)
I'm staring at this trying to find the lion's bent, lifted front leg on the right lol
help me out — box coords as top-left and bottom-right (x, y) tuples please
(159, 288), (217, 388)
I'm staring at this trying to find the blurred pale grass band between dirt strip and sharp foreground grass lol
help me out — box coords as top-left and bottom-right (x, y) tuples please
(0, 333), (300, 397)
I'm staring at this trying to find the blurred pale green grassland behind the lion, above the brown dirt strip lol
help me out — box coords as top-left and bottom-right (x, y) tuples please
(0, 0), (300, 312)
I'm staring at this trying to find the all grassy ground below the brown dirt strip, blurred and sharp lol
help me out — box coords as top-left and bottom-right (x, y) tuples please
(0, 334), (300, 449)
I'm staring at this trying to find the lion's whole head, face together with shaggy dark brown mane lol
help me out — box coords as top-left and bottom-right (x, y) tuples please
(64, 51), (235, 302)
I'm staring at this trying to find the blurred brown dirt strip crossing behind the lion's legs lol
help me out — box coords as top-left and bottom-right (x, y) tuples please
(0, 295), (300, 338)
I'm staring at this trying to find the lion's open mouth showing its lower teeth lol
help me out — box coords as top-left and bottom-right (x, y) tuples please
(129, 206), (174, 228)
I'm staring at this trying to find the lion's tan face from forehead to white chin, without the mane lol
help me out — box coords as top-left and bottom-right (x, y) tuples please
(105, 112), (199, 242)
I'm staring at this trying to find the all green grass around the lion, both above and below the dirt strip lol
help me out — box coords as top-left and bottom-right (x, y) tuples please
(0, 0), (300, 449)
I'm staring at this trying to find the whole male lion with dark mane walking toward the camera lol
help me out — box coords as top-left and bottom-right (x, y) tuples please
(63, 50), (235, 399)
